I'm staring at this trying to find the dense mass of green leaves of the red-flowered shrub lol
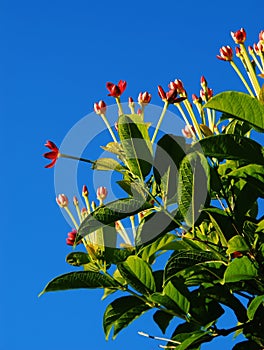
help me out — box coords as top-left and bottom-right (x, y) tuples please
(41, 28), (264, 350)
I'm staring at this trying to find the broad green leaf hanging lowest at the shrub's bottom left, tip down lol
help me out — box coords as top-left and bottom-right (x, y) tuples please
(103, 296), (150, 339)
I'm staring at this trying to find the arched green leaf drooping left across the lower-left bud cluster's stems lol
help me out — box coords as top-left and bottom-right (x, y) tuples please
(77, 198), (152, 241)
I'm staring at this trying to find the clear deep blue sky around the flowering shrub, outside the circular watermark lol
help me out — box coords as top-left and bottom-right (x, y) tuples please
(0, 0), (264, 350)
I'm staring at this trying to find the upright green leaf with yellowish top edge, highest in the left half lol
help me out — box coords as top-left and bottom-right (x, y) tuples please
(118, 114), (153, 179)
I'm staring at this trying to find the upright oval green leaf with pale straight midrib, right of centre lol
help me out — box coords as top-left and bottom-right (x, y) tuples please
(177, 152), (210, 227)
